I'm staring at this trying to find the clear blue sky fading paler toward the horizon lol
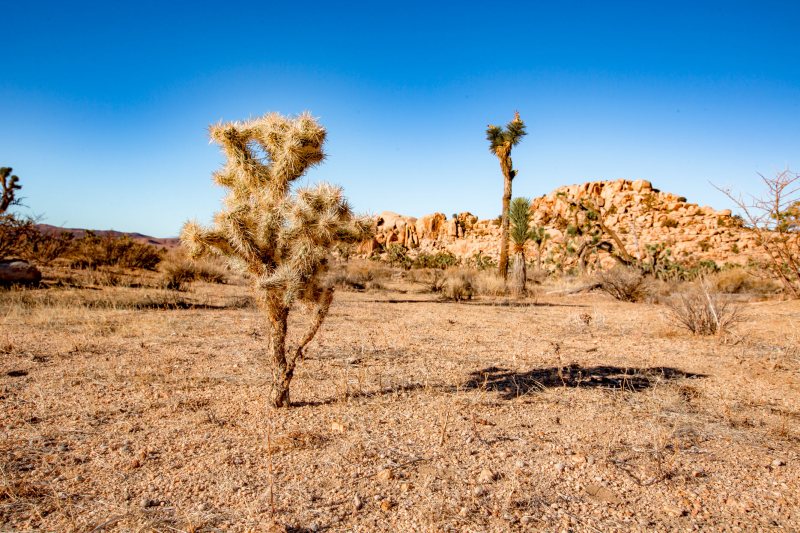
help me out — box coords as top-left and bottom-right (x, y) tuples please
(0, 0), (800, 236)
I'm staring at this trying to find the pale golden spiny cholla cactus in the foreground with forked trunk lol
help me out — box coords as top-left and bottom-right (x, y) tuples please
(181, 113), (372, 407)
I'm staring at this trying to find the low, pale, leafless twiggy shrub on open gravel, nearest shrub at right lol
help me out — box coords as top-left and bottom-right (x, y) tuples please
(666, 281), (741, 335)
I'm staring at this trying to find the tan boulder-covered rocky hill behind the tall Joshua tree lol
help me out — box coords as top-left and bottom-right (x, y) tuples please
(360, 180), (760, 265)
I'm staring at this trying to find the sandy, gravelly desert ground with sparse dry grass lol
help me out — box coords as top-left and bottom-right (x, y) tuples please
(0, 272), (800, 532)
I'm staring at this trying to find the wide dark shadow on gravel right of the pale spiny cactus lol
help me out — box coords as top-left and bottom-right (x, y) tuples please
(464, 363), (706, 399)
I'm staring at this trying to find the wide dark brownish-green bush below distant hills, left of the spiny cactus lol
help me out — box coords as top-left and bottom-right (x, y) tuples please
(69, 231), (164, 270)
